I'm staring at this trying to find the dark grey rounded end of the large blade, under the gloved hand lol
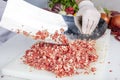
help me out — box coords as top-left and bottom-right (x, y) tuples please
(63, 16), (107, 40)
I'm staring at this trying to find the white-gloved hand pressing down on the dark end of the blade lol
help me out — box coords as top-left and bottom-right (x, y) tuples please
(74, 0), (100, 34)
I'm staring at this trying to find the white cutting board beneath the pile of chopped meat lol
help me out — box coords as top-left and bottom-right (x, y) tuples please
(0, 30), (110, 80)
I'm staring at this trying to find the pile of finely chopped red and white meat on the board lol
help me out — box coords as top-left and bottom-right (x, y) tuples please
(23, 28), (98, 77)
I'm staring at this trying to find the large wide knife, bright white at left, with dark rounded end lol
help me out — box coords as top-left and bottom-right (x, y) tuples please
(1, 0), (107, 42)
